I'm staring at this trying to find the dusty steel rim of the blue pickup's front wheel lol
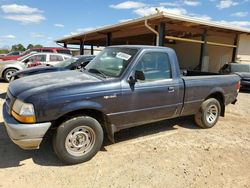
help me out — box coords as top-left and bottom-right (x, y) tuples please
(65, 126), (96, 157)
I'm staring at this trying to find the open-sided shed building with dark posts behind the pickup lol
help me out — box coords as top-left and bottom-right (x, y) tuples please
(56, 12), (250, 72)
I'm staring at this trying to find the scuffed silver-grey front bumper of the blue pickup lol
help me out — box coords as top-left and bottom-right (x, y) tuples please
(3, 103), (51, 149)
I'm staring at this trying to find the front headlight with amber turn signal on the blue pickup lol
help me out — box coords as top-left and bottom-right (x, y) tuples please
(11, 99), (36, 123)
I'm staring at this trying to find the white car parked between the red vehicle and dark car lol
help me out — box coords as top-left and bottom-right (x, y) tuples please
(0, 53), (71, 82)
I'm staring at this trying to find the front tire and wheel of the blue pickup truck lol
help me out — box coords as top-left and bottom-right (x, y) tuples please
(53, 116), (103, 164)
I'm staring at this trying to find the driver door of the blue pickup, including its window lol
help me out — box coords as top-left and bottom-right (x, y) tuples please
(112, 52), (183, 128)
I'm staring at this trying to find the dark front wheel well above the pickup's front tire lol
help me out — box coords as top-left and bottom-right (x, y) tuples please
(52, 109), (108, 131)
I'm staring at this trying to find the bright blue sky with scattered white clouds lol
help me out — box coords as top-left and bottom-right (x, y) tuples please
(0, 0), (250, 48)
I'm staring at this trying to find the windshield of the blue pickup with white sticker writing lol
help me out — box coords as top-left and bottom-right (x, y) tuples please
(85, 47), (138, 77)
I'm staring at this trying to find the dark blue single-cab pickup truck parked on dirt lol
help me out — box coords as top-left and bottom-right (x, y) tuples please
(3, 45), (240, 164)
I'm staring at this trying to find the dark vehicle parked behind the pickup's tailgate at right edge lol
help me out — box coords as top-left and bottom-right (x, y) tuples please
(219, 63), (250, 89)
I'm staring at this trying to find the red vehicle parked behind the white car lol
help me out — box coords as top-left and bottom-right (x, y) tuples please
(0, 47), (71, 61)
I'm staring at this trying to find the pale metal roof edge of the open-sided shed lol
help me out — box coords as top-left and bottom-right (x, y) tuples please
(55, 12), (250, 43)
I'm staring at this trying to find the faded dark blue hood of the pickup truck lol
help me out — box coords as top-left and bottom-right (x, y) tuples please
(9, 71), (101, 99)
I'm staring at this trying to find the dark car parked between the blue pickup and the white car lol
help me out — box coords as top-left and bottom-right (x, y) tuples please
(11, 55), (95, 81)
